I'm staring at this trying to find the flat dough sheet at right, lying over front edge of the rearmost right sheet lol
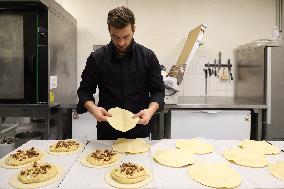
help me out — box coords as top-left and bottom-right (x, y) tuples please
(222, 148), (269, 167)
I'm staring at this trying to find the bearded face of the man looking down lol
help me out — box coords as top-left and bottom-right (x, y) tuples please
(109, 24), (134, 54)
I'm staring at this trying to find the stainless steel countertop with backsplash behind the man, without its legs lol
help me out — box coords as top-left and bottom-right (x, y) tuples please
(165, 96), (267, 110)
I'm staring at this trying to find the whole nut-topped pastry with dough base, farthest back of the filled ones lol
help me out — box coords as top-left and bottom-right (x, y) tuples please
(47, 140), (83, 155)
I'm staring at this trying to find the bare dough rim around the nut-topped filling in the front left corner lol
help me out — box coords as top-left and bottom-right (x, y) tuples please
(9, 162), (63, 189)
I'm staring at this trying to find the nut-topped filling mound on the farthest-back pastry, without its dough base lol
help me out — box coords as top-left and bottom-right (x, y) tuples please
(50, 140), (80, 152)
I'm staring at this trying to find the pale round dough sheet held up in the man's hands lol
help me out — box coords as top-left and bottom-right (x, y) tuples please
(107, 107), (139, 132)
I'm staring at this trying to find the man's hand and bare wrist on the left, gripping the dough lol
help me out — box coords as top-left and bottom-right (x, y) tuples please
(85, 101), (111, 122)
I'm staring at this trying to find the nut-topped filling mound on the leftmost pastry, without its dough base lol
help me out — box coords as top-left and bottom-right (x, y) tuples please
(6, 147), (42, 166)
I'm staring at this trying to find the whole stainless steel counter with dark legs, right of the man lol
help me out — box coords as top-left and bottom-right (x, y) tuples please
(153, 96), (267, 140)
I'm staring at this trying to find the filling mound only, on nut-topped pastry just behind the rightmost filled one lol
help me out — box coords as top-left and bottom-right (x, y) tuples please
(87, 150), (118, 165)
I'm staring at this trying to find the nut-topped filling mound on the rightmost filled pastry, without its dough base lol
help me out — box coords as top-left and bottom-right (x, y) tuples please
(111, 162), (147, 184)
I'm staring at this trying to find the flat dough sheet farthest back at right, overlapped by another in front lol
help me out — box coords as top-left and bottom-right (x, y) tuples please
(239, 139), (280, 154)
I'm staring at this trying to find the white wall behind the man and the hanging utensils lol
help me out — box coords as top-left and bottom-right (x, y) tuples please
(59, 0), (276, 96)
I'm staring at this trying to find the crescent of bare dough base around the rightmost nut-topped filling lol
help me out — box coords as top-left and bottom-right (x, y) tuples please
(105, 169), (153, 188)
